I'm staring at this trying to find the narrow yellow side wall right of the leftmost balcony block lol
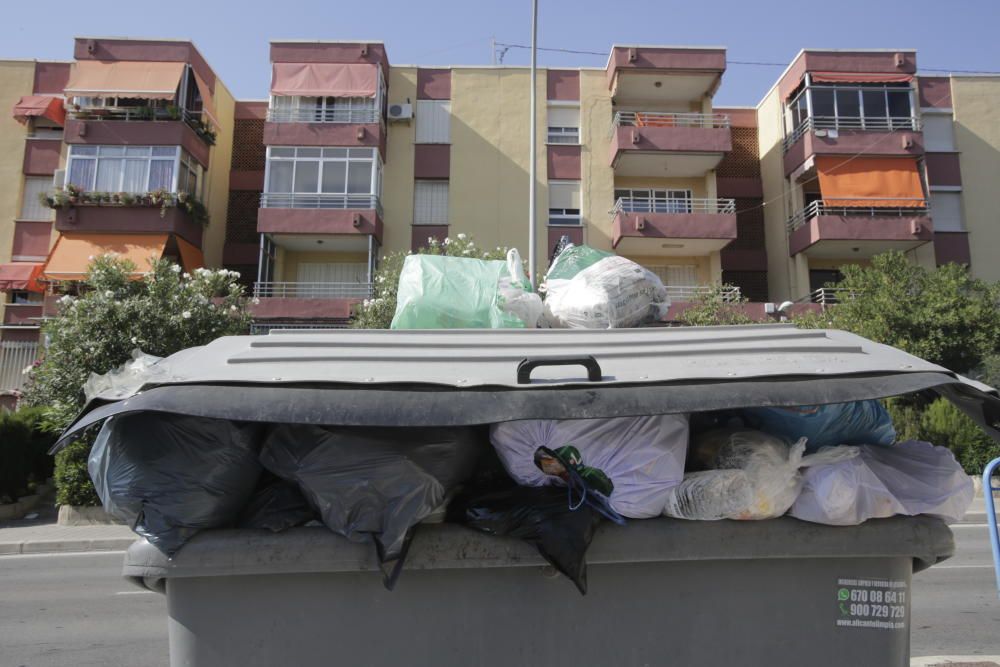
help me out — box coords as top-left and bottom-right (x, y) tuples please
(201, 78), (236, 267)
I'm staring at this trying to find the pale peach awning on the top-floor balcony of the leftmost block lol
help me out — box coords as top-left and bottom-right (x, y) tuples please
(65, 60), (184, 100)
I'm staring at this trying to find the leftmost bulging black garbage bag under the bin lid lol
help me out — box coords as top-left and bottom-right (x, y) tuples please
(87, 412), (262, 556)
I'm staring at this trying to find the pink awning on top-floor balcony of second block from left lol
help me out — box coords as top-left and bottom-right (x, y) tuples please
(271, 63), (378, 97)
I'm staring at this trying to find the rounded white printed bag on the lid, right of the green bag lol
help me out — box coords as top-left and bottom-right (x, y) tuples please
(544, 256), (670, 329)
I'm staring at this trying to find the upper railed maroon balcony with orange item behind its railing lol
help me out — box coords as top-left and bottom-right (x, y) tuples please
(609, 111), (732, 178)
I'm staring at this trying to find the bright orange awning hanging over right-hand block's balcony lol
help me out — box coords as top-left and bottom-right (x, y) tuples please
(816, 156), (926, 208)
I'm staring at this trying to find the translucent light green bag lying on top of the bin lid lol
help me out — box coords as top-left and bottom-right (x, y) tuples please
(390, 251), (542, 329)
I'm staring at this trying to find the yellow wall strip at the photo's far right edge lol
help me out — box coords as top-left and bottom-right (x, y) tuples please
(951, 76), (1000, 281)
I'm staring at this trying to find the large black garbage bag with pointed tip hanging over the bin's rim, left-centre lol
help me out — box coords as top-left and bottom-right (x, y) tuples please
(260, 424), (490, 588)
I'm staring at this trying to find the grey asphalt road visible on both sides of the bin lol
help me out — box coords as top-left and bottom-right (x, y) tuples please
(0, 508), (1000, 667)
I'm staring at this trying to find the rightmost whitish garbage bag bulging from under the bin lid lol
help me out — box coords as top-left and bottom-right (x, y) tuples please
(790, 440), (975, 526)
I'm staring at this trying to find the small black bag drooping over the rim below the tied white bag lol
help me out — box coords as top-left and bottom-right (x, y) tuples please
(449, 486), (601, 595)
